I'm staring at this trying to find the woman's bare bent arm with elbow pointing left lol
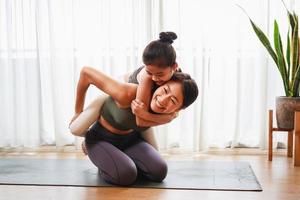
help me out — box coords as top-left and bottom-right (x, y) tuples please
(75, 67), (137, 114)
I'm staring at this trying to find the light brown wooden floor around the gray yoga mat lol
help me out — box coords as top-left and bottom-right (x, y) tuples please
(0, 149), (300, 200)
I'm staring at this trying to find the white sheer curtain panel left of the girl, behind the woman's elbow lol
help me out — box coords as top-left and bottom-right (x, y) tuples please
(0, 0), (150, 147)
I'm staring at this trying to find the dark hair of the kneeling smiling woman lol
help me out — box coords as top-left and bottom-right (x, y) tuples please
(171, 72), (198, 109)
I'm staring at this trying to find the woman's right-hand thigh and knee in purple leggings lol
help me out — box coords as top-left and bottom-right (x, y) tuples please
(124, 140), (168, 182)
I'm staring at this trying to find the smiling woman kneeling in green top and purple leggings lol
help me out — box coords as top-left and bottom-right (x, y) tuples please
(75, 67), (198, 185)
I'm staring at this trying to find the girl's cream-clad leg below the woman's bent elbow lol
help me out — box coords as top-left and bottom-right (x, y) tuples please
(69, 94), (108, 137)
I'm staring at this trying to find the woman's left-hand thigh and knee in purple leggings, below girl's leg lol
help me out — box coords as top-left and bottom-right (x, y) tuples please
(86, 141), (137, 186)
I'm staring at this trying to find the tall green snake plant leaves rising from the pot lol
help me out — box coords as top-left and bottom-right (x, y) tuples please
(243, 3), (300, 97)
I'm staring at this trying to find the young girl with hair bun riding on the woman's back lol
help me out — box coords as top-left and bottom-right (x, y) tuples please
(70, 32), (178, 149)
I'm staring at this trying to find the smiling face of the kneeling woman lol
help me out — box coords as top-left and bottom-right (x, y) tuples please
(150, 81), (183, 114)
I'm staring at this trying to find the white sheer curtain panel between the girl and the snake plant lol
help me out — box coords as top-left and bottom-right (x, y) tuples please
(155, 0), (268, 150)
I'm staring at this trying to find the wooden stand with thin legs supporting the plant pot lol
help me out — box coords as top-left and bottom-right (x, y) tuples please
(268, 110), (300, 166)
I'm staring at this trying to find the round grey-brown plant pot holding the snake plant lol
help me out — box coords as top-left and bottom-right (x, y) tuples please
(276, 97), (300, 129)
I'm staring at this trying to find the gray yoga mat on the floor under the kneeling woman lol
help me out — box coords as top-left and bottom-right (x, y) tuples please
(0, 158), (262, 191)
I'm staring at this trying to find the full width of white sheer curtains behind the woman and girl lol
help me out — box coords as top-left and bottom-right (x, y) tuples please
(0, 0), (299, 150)
